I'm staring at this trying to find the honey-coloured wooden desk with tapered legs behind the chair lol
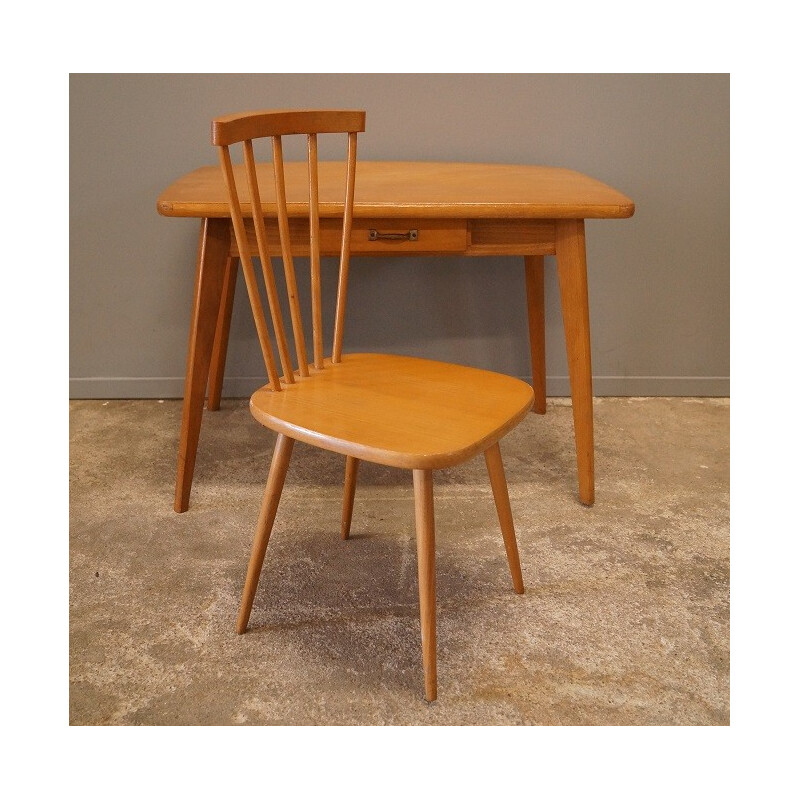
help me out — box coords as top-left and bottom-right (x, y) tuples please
(157, 161), (634, 511)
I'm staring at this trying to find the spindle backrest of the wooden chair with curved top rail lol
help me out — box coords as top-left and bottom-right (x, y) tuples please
(211, 110), (366, 392)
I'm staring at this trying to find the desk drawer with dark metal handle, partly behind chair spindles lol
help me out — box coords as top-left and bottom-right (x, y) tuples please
(231, 217), (467, 256)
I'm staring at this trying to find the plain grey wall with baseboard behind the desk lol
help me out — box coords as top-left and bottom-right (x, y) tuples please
(70, 74), (730, 398)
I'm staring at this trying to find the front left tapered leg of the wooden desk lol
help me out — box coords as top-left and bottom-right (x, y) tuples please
(174, 219), (231, 512)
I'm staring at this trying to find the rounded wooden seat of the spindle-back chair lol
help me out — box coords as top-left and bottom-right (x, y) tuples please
(250, 353), (533, 469)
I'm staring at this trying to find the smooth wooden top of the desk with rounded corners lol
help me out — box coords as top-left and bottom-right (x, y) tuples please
(157, 161), (634, 219)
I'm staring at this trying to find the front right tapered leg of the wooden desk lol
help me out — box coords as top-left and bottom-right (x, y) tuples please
(556, 219), (594, 506)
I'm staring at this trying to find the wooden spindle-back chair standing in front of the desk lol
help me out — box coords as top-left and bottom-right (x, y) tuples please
(212, 110), (533, 701)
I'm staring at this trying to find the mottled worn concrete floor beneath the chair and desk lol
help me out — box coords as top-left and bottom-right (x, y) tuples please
(69, 398), (730, 725)
